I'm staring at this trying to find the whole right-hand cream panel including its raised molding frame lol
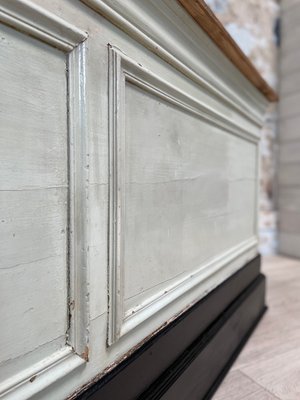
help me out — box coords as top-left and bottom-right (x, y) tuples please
(109, 44), (258, 343)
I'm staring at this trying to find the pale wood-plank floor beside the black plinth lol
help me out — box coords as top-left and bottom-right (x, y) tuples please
(213, 256), (300, 400)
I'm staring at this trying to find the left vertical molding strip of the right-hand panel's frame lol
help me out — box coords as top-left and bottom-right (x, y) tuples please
(108, 46), (125, 345)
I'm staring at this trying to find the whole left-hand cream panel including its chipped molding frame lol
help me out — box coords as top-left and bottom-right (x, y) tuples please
(0, 1), (87, 398)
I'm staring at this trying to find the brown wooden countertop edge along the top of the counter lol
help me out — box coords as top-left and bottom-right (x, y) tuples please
(178, 0), (278, 102)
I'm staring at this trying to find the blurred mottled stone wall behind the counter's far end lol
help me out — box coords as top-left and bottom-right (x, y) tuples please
(206, 0), (279, 254)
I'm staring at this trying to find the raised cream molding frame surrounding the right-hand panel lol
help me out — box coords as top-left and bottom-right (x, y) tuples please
(108, 45), (259, 345)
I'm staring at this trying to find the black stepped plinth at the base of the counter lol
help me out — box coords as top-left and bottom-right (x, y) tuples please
(78, 256), (266, 400)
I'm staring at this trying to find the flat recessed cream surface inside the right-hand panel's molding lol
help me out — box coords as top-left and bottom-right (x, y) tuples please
(122, 82), (256, 316)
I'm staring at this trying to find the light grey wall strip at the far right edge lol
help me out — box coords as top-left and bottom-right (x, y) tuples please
(278, 0), (300, 257)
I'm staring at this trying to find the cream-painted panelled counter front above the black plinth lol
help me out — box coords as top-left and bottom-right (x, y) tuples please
(0, 0), (276, 400)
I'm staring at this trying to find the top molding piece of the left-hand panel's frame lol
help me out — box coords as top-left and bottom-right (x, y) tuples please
(0, 0), (88, 52)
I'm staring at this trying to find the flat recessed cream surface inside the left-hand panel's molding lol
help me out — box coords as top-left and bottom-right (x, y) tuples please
(0, 25), (68, 363)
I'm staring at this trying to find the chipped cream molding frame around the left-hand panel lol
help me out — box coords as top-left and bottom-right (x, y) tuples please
(0, 0), (89, 399)
